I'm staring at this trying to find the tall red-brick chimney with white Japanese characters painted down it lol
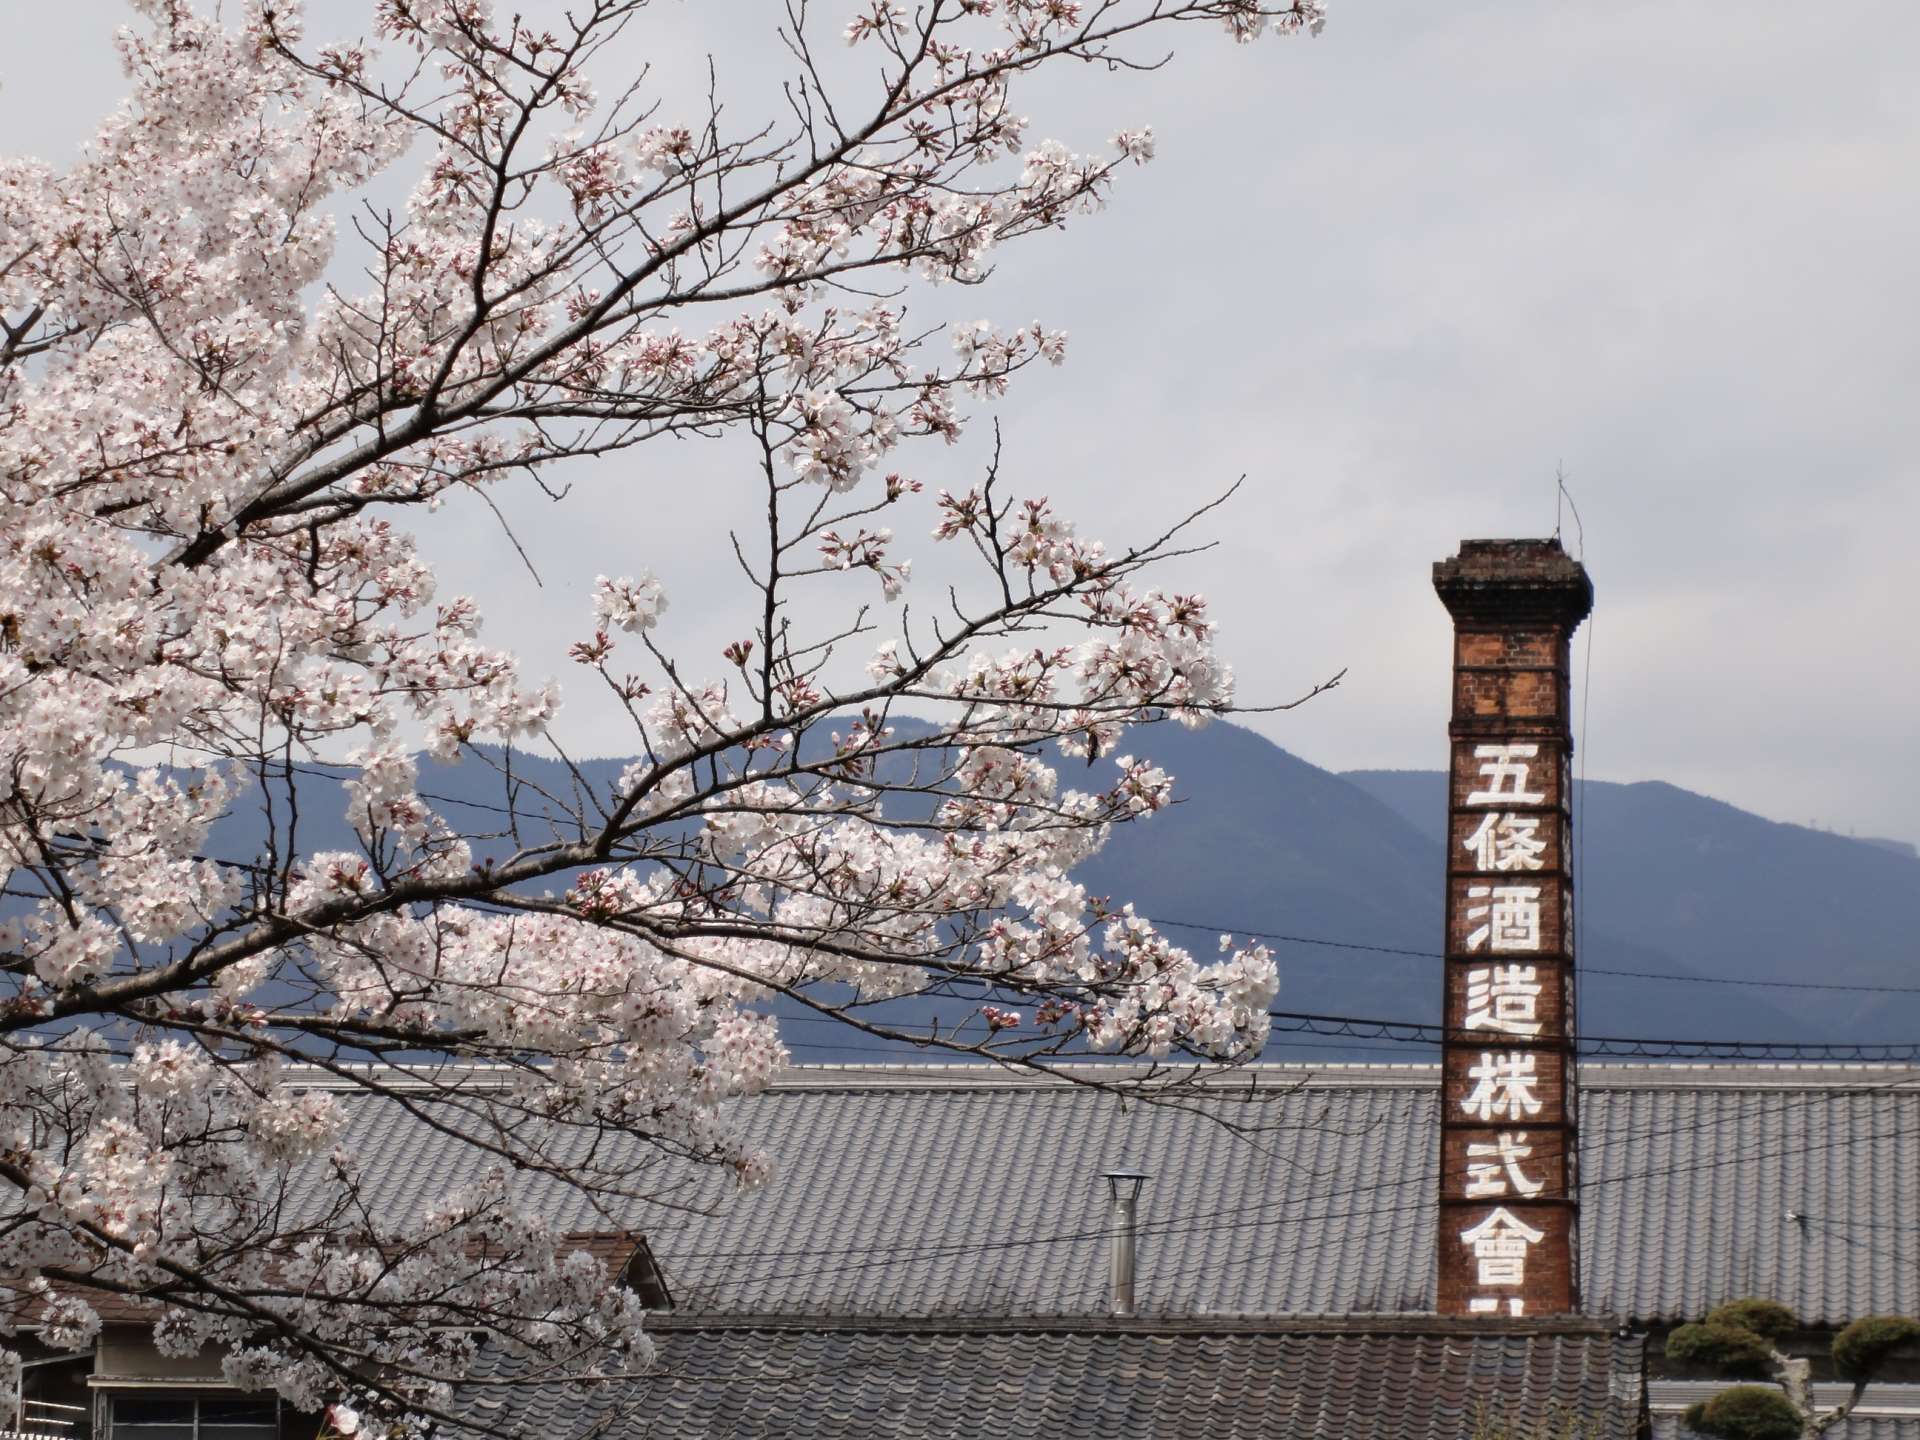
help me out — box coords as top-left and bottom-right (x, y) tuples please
(1434, 540), (1594, 1315)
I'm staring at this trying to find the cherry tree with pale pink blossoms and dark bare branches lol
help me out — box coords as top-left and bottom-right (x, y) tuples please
(0, 0), (1321, 1425)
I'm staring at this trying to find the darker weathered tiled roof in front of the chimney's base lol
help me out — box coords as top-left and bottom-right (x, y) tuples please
(476, 1321), (1642, 1440)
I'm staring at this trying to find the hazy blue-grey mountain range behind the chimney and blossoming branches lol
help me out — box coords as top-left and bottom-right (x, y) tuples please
(198, 722), (1920, 1062)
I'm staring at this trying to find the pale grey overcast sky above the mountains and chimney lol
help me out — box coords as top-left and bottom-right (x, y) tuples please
(0, 0), (1920, 839)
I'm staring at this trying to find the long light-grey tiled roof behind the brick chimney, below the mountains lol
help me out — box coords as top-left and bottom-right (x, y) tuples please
(318, 1066), (1920, 1325)
